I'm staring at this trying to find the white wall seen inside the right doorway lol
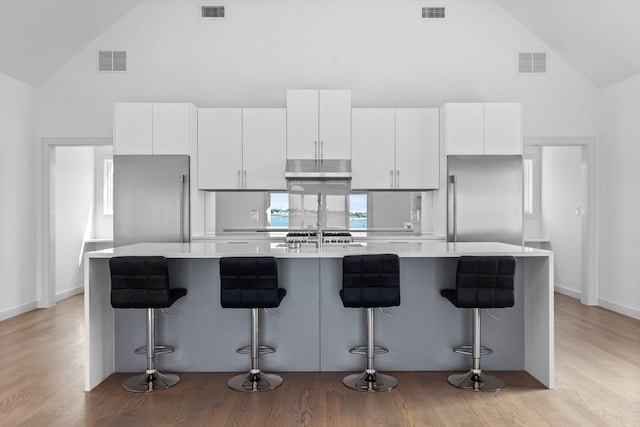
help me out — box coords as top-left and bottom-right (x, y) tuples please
(540, 147), (582, 298)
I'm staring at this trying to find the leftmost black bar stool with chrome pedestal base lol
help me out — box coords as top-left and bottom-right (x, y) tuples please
(109, 256), (187, 392)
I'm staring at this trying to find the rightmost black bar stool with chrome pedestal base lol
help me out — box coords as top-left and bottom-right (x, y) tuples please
(440, 256), (516, 391)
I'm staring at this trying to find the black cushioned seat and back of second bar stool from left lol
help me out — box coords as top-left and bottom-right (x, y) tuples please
(220, 257), (287, 308)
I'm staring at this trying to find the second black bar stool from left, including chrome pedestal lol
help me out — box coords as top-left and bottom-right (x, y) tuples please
(220, 257), (287, 392)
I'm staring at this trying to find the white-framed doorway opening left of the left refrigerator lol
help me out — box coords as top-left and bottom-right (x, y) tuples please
(38, 138), (113, 308)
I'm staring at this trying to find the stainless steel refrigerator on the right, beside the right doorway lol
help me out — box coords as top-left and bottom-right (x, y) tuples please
(447, 156), (523, 245)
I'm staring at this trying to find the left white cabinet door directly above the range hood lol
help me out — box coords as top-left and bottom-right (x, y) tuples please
(287, 89), (318, 159)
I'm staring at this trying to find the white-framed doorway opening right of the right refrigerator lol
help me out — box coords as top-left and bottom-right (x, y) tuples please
(525, 138), (597, 305)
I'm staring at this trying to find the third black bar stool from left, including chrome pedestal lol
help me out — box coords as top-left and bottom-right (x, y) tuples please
(340, 254), (400, 392)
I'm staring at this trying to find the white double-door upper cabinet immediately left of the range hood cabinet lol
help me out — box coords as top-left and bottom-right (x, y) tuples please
(198, 108), (287, 190)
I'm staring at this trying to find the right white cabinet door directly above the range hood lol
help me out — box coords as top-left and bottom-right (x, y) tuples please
(318, 90), (351, 159)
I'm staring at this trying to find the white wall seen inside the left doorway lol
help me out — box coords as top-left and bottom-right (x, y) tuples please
(54, 147), (95, 300)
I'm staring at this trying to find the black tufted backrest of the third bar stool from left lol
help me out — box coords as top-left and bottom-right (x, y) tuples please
(340, 254), (400, 308)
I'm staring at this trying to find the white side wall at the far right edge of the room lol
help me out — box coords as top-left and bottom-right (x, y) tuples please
(598, 74), (640, 318)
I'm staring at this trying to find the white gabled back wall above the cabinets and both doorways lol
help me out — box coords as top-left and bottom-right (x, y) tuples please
(38, 0), (598, 136)
